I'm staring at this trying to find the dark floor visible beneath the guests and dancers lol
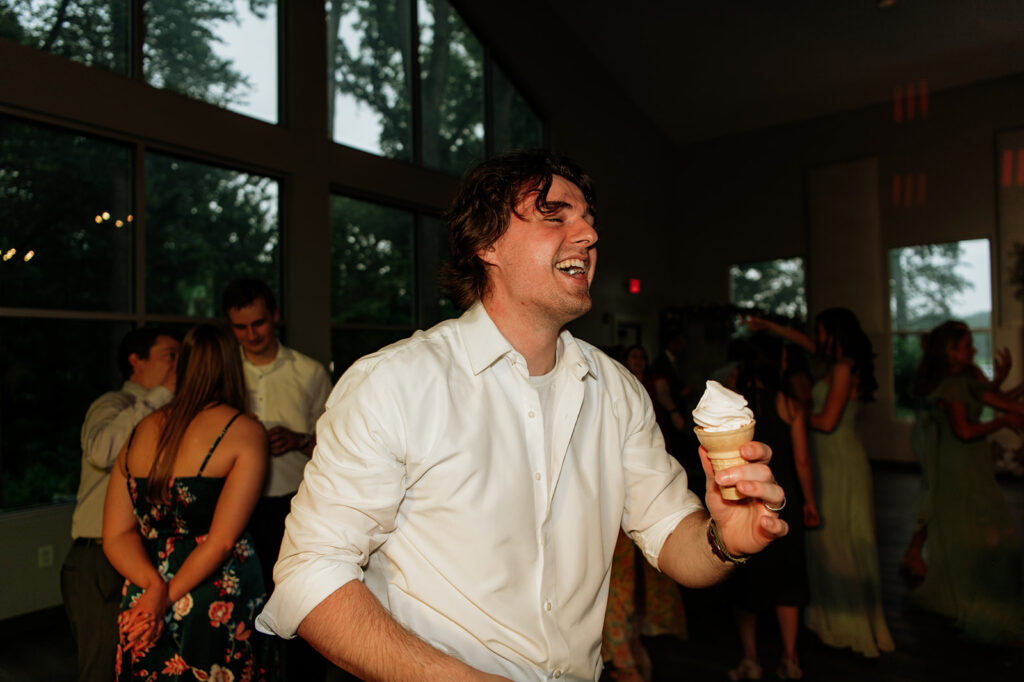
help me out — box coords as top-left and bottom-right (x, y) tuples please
(0, 466), (1024, 682)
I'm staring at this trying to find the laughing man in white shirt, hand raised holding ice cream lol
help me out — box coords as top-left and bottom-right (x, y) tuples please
(257, 152), (786, 680)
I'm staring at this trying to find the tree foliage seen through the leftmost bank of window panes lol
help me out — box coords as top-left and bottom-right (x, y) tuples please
(0, 0), (280, 508)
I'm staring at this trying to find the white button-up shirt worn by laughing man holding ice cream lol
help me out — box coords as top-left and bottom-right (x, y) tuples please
(257, 304), (702, 680)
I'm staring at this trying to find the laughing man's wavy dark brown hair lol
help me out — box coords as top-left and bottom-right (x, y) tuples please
(440, 150), (594, 309)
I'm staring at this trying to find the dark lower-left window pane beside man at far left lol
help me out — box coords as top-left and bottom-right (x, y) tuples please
(0, 317), (130, 511)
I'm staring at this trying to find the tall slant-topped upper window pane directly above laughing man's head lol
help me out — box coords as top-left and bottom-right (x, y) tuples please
(417, 0), (484, 175)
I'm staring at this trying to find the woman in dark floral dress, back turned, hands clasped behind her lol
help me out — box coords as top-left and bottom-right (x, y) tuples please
(103, 325), (267, 682)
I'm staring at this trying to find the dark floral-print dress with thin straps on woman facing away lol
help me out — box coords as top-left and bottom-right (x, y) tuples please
(115, 415), (266, 682)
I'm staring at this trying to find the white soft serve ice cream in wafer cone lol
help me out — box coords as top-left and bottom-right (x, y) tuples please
(693, 381), (755, 500)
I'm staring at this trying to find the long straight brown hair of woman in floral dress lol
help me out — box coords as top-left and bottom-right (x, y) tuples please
(145, 324), (246, 504)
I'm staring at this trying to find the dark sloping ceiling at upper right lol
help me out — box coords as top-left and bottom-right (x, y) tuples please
(547, 0), (1024, 144)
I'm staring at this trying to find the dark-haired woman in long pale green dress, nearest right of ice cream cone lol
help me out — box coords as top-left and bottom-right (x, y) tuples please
(746, 307), (894, 657)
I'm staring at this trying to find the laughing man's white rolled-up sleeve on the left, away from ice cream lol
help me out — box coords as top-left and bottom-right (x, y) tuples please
(256, 358), (406, 638)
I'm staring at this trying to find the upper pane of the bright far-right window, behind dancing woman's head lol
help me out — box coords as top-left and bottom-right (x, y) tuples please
(889, 240), (992, 332)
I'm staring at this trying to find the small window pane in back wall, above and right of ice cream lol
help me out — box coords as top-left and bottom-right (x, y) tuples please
(729, 258), (807, 319)
